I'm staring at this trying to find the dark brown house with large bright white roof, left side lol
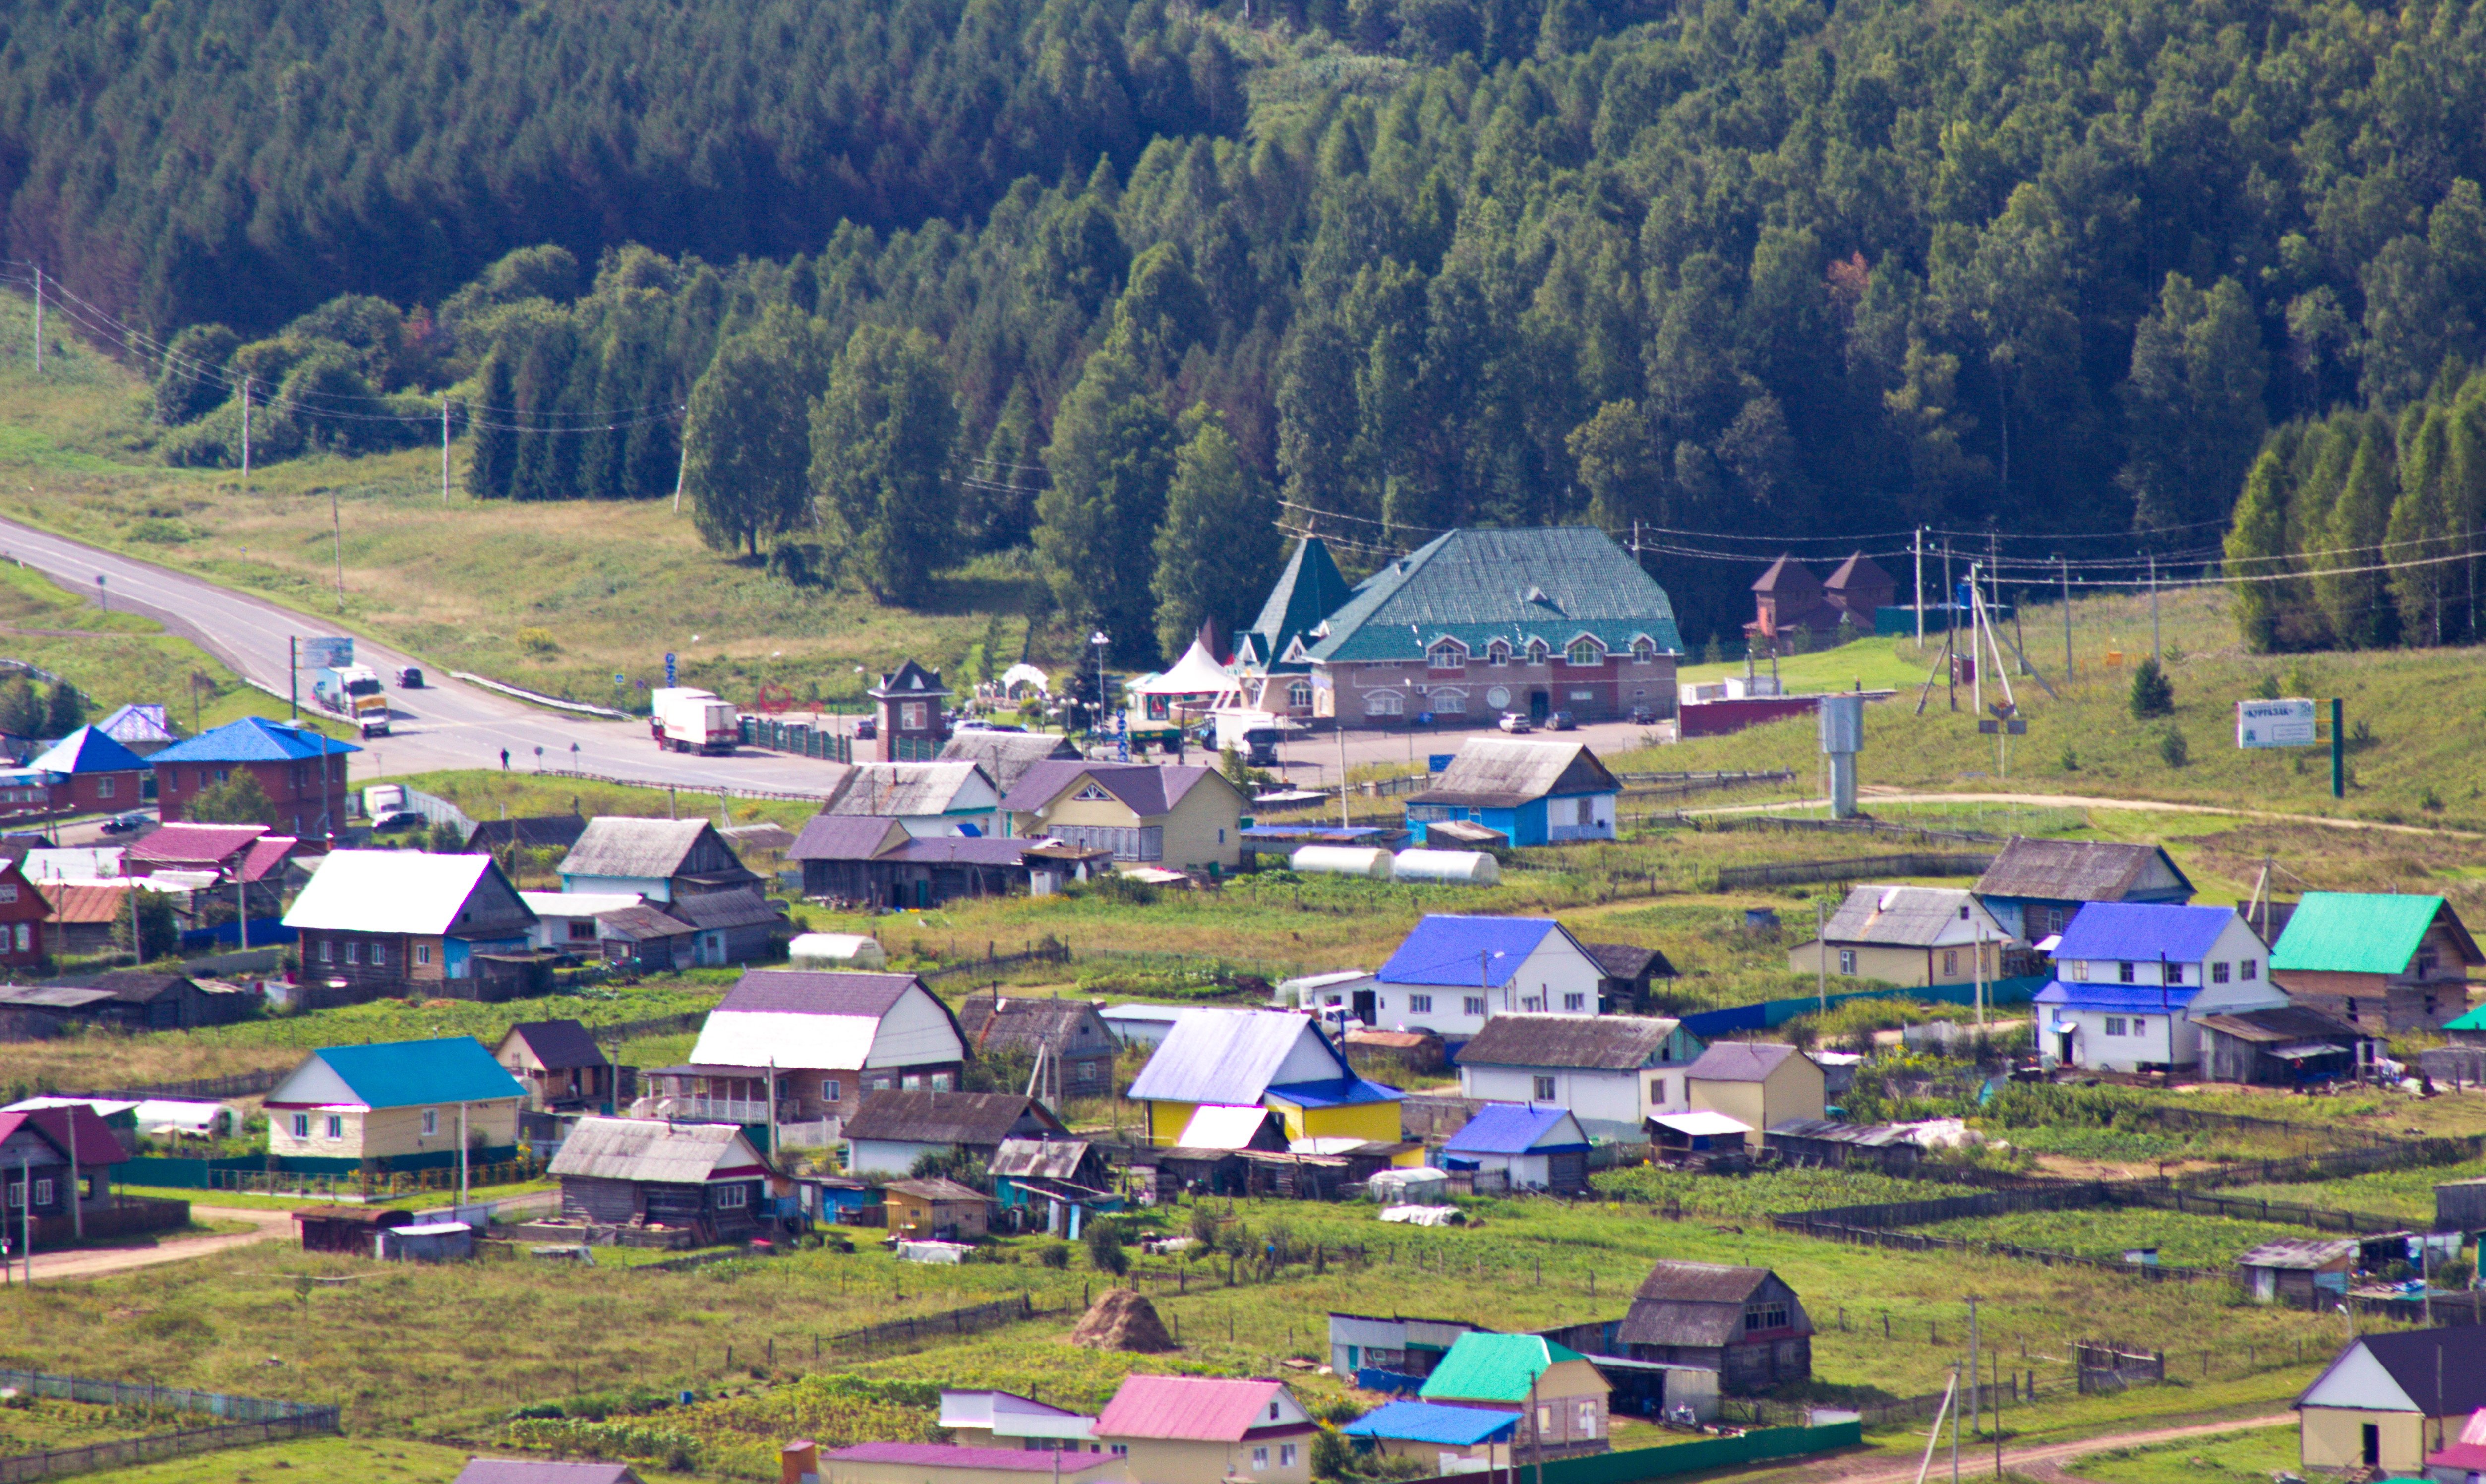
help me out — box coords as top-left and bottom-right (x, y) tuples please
(286, 850), (534, 1007)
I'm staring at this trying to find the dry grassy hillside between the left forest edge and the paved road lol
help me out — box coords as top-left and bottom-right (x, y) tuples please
(0, 296), (1037, 704)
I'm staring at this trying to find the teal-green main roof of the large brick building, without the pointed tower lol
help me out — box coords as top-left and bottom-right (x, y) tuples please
(1312, 525), (1683, 661)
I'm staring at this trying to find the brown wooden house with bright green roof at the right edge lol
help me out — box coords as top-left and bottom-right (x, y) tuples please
(2270, 892), (2486, 1032)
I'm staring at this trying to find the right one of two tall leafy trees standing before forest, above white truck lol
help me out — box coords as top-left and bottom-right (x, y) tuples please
(811, 326), (957, 606)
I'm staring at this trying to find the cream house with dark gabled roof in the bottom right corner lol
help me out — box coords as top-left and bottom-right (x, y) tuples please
(2297, 1325), (2486, 1477)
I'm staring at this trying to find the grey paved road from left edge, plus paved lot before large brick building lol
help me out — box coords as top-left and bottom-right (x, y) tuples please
(0, 520), (1646, 793)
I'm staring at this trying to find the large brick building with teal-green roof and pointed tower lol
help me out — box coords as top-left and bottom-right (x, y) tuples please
(1241, 527), (1683, 726)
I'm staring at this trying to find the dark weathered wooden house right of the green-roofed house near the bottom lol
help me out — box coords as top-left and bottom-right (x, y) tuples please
(1616, 1263), (1812, 1395)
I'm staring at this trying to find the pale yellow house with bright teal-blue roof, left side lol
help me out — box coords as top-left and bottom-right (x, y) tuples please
(266, 1037), (527, 1168)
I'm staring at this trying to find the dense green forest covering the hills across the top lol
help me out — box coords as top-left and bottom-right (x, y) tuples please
(14, 0), (2486, 652)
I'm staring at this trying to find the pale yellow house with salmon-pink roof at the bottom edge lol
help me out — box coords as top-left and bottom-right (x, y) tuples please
(1096, 1374), (1320, 1484)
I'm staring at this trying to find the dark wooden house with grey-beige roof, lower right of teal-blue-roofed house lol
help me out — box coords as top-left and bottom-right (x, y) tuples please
(547, 1116), (770, 1243)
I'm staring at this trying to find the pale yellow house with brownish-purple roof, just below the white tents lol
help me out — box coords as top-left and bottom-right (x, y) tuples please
(1002, 758), (1248, 870)
